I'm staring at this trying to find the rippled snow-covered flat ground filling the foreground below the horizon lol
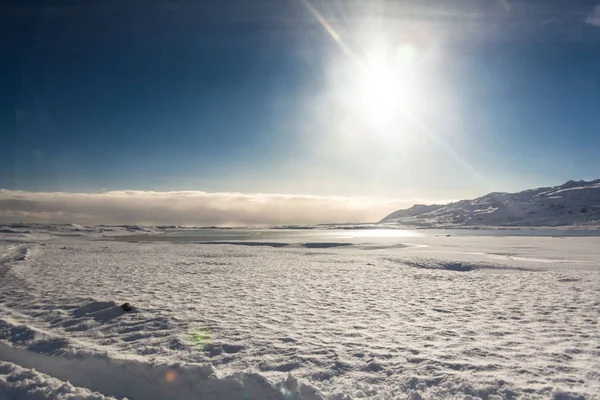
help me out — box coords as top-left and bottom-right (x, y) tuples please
(0, 226), (600, 400)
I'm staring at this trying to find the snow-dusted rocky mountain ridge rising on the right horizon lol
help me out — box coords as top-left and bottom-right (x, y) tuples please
(380, 179), (600, 227)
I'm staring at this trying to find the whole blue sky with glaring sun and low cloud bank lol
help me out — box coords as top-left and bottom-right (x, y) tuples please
(0, 0), (600, 224)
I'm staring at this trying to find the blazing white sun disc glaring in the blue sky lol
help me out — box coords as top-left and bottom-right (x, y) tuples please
(359, 44), (415, 127)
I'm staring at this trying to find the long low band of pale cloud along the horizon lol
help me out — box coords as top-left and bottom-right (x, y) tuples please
(0, 189), (440, 225)
